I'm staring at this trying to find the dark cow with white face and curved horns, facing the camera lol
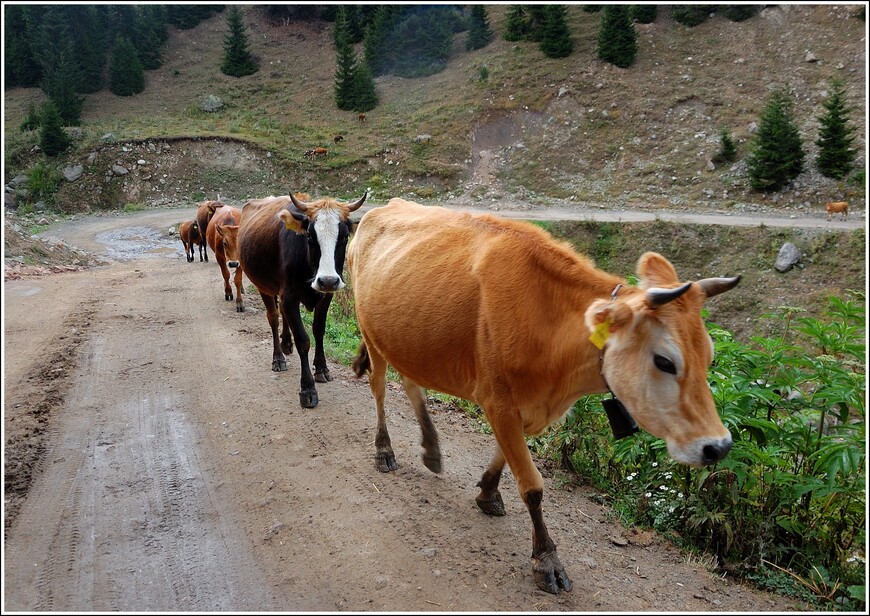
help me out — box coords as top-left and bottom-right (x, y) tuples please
(238, 192), (368, 408)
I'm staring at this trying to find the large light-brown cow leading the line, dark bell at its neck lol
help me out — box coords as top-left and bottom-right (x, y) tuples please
(348, 199), (740, 593)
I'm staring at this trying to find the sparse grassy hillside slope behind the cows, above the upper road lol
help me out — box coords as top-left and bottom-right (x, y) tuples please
(4, 4), (866, 211)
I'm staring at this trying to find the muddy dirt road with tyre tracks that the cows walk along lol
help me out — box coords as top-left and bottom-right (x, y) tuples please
(3, 210), (806, 613)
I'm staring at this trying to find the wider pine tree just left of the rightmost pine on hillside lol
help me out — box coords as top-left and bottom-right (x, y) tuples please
(747, 90), (804, 191)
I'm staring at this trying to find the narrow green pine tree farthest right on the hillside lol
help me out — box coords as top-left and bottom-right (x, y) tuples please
(816, 79), (856, 180)
